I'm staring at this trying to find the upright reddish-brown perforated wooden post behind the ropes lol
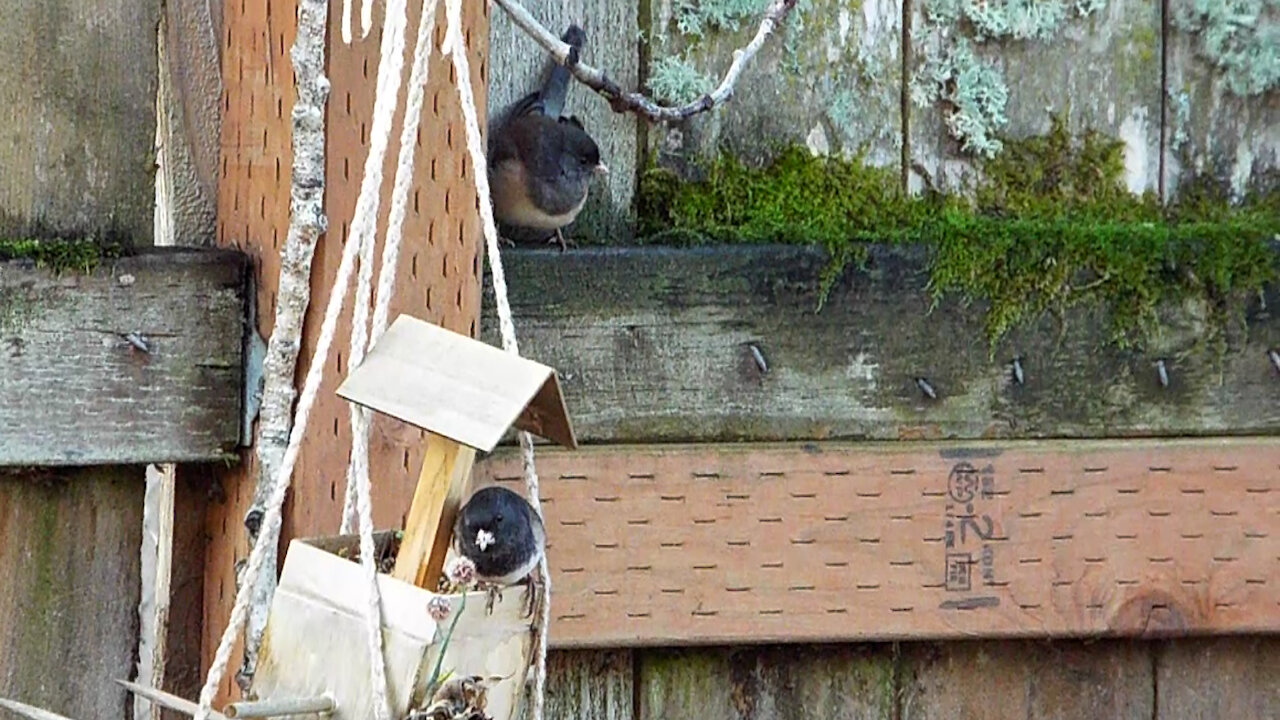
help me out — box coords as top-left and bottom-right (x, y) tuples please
(204, 0), (488, 692)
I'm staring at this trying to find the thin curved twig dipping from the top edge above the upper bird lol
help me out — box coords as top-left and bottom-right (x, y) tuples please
(493, 0), (799, 123)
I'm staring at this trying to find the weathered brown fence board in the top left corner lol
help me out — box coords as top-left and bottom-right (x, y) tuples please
(0, 0), (160, 245)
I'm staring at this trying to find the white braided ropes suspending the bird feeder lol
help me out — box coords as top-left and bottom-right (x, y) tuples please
(196, 0), (550, 720)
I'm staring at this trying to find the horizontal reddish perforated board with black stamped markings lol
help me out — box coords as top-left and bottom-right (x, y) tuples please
(480, 439), (1280, 647)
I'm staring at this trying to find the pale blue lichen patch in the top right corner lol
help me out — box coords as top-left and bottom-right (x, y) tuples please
(1171, 0), (1280, 96)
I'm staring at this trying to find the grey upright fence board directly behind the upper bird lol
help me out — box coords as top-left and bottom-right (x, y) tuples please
(484, 0), (641, 242)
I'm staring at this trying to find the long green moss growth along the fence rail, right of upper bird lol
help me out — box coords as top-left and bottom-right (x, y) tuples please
(637, 119), (1280, 345)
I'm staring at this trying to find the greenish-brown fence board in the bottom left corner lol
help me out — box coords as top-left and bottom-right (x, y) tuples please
(0, 466), (143, 720)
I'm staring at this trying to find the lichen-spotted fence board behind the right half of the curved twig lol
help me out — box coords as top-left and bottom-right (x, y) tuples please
(646, 0), (902, 176)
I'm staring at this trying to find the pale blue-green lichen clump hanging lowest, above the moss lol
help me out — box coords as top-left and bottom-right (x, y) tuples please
(909, 37), (1009, 158)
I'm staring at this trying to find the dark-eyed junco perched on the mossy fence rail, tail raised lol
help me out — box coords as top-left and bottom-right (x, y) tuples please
(488, 26), (608, 250)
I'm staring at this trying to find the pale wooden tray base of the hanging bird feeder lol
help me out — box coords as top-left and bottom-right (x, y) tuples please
(252, 532), (532, 720)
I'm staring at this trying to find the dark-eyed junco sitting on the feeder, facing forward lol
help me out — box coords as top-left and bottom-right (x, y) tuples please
(453, 486), (547, 604)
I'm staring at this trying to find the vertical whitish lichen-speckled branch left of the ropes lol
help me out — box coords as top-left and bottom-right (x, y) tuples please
(236, 0), (329, 692)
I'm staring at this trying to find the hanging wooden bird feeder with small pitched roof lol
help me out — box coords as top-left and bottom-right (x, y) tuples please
(244, 315), (577, 720)
